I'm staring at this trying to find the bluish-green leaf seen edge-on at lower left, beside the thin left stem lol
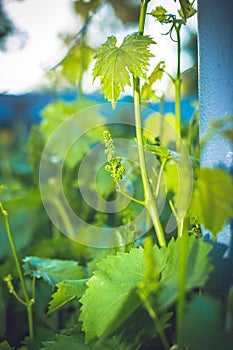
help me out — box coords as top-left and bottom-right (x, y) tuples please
(23, 256), (84, 288)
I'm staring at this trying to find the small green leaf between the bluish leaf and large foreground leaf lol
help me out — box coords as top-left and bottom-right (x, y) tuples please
(48, 279), (88, 315)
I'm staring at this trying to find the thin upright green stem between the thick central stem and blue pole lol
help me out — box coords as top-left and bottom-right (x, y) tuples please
(174, 24), (181, 151)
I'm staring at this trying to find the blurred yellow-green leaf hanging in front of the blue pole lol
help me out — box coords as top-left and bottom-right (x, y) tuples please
(191, 168), (233, 239)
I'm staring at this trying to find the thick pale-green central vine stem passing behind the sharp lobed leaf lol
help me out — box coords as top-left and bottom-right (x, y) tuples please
(133, 0), (166, 247)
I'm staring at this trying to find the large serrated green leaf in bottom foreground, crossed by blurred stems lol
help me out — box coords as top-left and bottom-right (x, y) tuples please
(80, 237), (212, 342)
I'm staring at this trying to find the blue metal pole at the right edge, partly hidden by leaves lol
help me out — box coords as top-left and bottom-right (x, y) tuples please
(198, 0), (233, 244)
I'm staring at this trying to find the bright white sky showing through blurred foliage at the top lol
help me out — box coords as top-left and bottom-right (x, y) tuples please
(0, 0), (196, 94)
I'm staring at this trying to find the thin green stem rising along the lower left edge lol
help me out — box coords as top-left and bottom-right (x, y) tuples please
(0, 203), (34, 339)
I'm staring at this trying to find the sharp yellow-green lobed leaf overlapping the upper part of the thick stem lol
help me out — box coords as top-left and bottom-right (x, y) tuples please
(93, 34), (154, 108)
